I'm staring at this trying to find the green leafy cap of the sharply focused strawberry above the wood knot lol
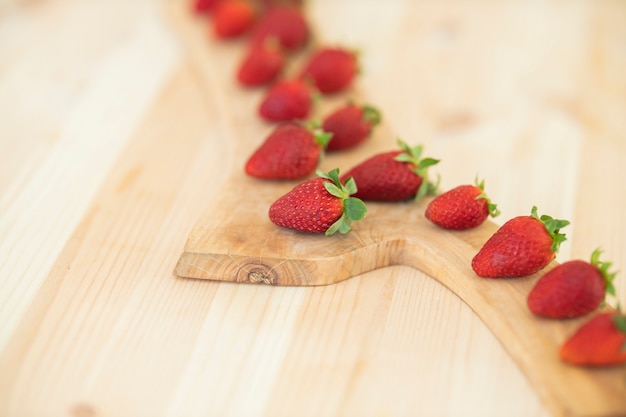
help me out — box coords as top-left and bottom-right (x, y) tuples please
(316, 168), (367, 236)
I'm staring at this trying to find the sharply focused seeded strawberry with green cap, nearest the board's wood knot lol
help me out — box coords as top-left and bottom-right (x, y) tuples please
(269, 169), (367, 236)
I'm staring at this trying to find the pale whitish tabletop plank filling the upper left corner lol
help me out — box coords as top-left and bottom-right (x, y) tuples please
(0, 3), (178, 354)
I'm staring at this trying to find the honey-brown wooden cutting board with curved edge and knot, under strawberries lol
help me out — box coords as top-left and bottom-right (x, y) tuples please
(171, 1), (626, 416)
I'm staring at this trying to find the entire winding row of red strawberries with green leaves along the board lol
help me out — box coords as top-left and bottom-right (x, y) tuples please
(193, 0), (626, 366)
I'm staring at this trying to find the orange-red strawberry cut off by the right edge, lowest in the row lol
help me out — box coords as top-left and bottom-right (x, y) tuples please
(559, 312), (626, 366)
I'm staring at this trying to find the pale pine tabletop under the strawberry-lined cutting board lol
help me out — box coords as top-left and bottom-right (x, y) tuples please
(0, 0), (626, 416)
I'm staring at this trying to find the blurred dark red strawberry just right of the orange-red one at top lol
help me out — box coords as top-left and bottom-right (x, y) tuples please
(251, 5), (310, 51)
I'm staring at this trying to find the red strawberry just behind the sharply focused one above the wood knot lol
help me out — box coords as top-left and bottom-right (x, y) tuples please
(245, 122), (332, 180)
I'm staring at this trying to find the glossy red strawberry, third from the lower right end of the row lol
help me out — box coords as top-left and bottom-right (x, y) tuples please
(472, 207), (569, 278)
